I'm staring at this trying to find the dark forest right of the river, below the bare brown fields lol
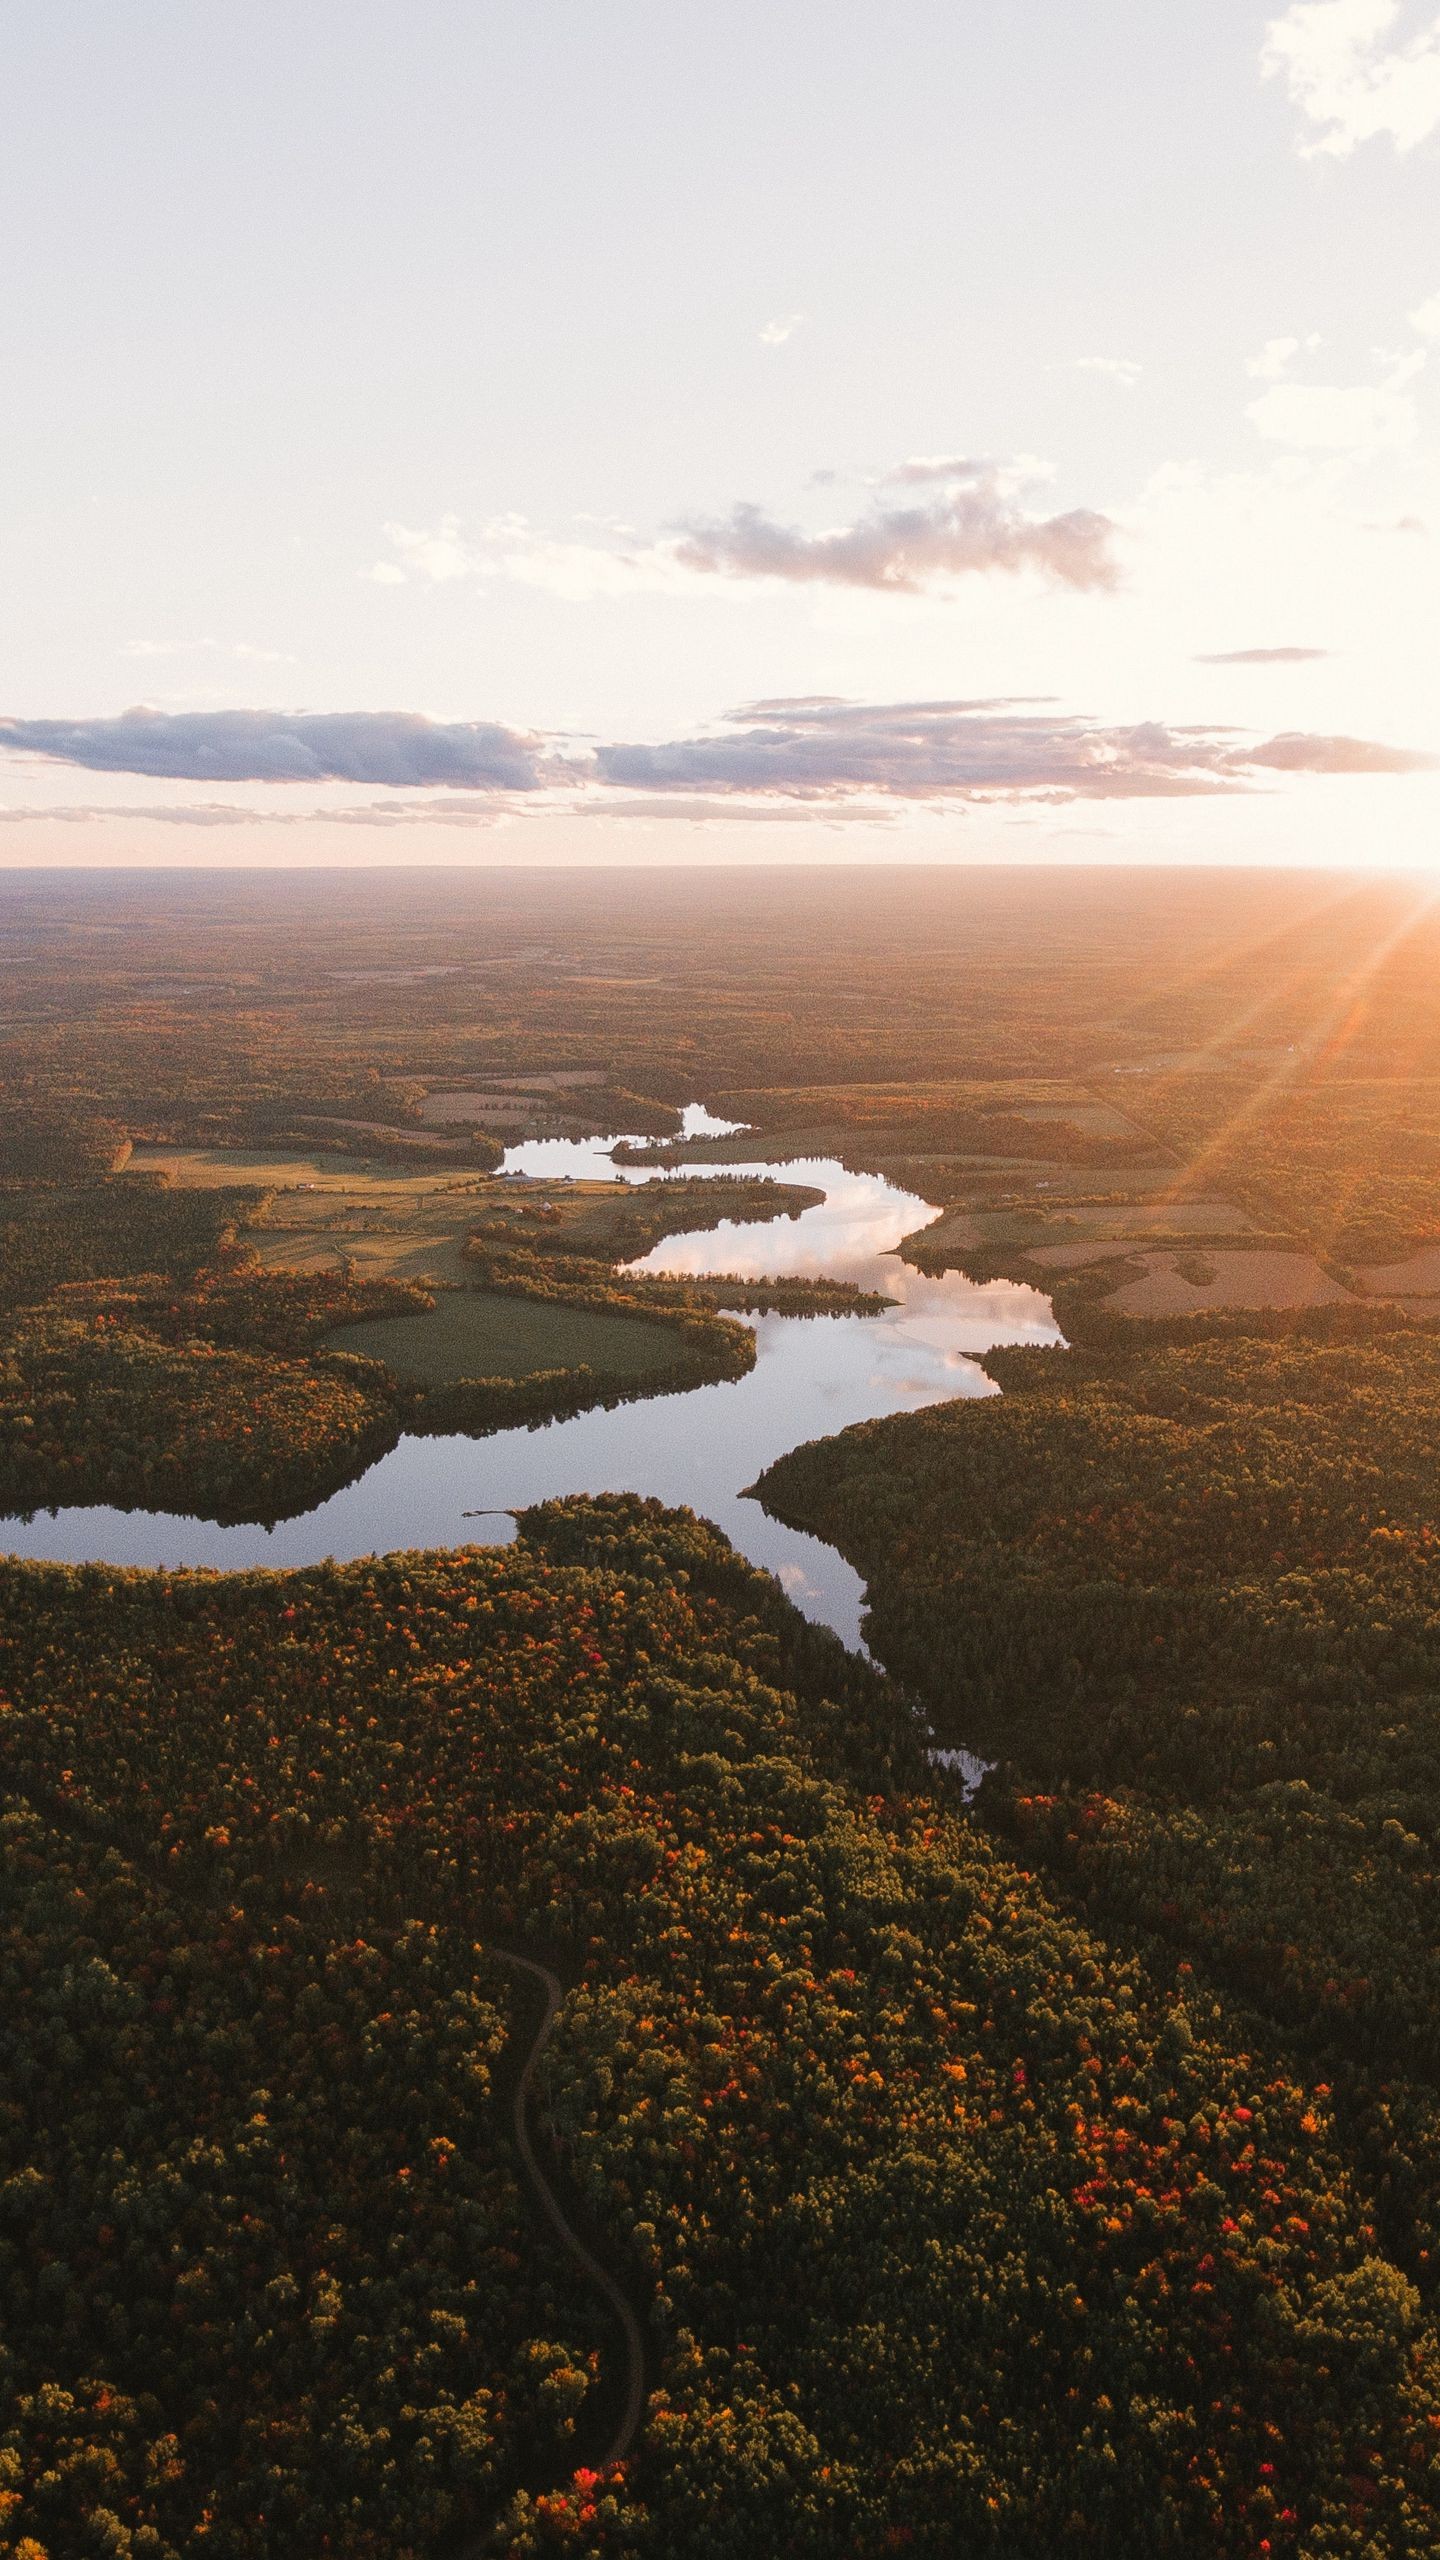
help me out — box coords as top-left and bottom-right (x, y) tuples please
(766, 1311), (1440, 2201)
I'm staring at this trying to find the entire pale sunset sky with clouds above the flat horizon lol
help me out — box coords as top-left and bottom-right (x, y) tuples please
(0, 0), (1440, 865)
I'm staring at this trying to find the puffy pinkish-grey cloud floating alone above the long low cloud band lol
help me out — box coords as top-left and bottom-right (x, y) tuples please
(674, 458), (1117, 594)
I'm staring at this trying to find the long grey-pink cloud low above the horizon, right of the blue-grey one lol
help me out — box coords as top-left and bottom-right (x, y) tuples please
(594, 694), (1437, 801)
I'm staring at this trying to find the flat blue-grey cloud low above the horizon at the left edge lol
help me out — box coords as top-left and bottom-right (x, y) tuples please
(0, 709), (551, 791)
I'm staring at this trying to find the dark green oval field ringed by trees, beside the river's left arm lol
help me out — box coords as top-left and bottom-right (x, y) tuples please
(328, 1290), (682, 1388)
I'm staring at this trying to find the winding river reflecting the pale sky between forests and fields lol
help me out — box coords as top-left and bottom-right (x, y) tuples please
(0, 1106), (1061, 1646)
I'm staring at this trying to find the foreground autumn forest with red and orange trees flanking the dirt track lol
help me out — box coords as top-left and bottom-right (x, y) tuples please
(0, 1500), (1440, 2560)
